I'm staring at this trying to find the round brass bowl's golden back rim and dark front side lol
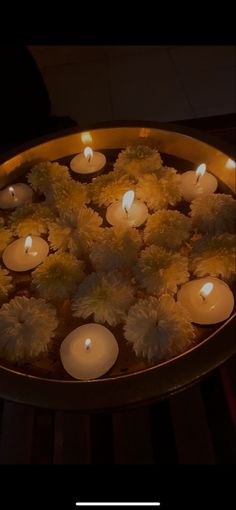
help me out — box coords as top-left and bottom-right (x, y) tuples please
(0, 122), (236, 412)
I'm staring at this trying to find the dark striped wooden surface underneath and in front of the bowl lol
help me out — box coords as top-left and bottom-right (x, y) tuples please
(0, 357), (236, 465)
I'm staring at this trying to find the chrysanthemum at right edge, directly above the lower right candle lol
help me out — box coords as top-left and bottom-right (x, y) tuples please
(190, 234), (236, 280)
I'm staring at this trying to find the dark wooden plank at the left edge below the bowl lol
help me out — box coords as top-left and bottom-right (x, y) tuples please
(0, 400), (34, 464)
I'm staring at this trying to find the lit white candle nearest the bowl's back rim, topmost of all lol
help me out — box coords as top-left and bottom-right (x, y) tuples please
(70, 147), (106, 174)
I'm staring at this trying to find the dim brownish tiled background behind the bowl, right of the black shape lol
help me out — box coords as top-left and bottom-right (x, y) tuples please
(29, 46), (236, 124)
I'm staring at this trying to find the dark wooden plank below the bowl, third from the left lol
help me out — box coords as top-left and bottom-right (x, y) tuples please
(113, 406), (154, 464)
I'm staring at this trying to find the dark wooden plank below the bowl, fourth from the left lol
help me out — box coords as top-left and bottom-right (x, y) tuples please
(170, 384), (215, 464)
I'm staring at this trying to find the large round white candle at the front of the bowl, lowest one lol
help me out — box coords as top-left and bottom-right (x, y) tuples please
(60, 323), (119, 380)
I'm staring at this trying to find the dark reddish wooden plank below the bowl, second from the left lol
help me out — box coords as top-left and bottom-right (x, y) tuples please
(53, 411), (91, 464)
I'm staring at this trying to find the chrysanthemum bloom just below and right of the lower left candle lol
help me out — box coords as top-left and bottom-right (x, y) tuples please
(32, 253), (85, 300)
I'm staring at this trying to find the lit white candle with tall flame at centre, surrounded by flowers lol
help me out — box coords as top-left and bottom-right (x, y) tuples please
(106, 190), (148, 227)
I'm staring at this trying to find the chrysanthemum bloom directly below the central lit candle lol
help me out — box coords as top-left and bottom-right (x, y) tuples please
(90, 227), (142, 271)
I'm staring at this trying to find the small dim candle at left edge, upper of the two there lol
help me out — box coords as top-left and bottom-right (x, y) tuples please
(0, 182), (33, 209)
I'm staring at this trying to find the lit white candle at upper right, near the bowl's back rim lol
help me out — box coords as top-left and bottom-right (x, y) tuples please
(181, 163), (218, 202)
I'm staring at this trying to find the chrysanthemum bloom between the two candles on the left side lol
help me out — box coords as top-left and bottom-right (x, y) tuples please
(10, 203), (55, 237)
